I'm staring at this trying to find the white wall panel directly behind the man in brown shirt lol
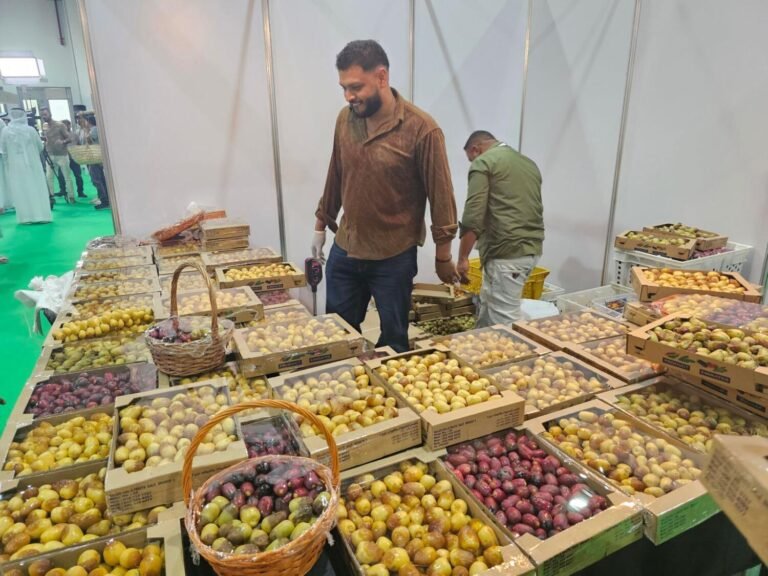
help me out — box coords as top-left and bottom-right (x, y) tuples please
(270, 0), (408, 311)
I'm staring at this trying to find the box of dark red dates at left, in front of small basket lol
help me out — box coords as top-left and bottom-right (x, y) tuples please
(15, 364), (157, 422)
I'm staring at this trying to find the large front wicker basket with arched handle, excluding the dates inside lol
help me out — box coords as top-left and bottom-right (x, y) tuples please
(181, 400), (340, 576)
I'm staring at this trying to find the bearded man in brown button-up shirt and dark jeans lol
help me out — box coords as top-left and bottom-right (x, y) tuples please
(312, 40), (458, 351)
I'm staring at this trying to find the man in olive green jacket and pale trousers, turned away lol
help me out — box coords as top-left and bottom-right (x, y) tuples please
(456, 130), (544, 327)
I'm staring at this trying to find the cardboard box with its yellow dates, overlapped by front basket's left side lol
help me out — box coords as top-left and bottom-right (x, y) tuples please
(106, 380), (247, 514)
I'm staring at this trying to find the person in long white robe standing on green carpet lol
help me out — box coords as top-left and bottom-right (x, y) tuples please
(0, 108), (51, 224)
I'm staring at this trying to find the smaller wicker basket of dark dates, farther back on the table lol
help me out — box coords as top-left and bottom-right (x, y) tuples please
(144, 262), (235, 376)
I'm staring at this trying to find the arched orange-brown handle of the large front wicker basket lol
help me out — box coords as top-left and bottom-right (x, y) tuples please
(181, 400), (340, 506)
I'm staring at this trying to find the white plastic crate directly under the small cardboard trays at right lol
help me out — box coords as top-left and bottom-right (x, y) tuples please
(613, 242), (752, 286)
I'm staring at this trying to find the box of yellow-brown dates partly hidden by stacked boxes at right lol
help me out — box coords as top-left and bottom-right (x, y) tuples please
(565, 336), (665, 384)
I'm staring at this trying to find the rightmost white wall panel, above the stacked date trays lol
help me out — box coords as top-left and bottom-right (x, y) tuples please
(616, 0), (768, 282)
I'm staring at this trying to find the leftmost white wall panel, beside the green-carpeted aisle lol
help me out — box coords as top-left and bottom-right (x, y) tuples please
(85, 0), (279, 248)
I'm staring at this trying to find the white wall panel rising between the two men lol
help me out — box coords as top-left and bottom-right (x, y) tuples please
(414, 0), (528, 282)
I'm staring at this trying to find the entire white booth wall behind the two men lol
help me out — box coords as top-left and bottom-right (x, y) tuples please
(81, 0), (768, 310)
